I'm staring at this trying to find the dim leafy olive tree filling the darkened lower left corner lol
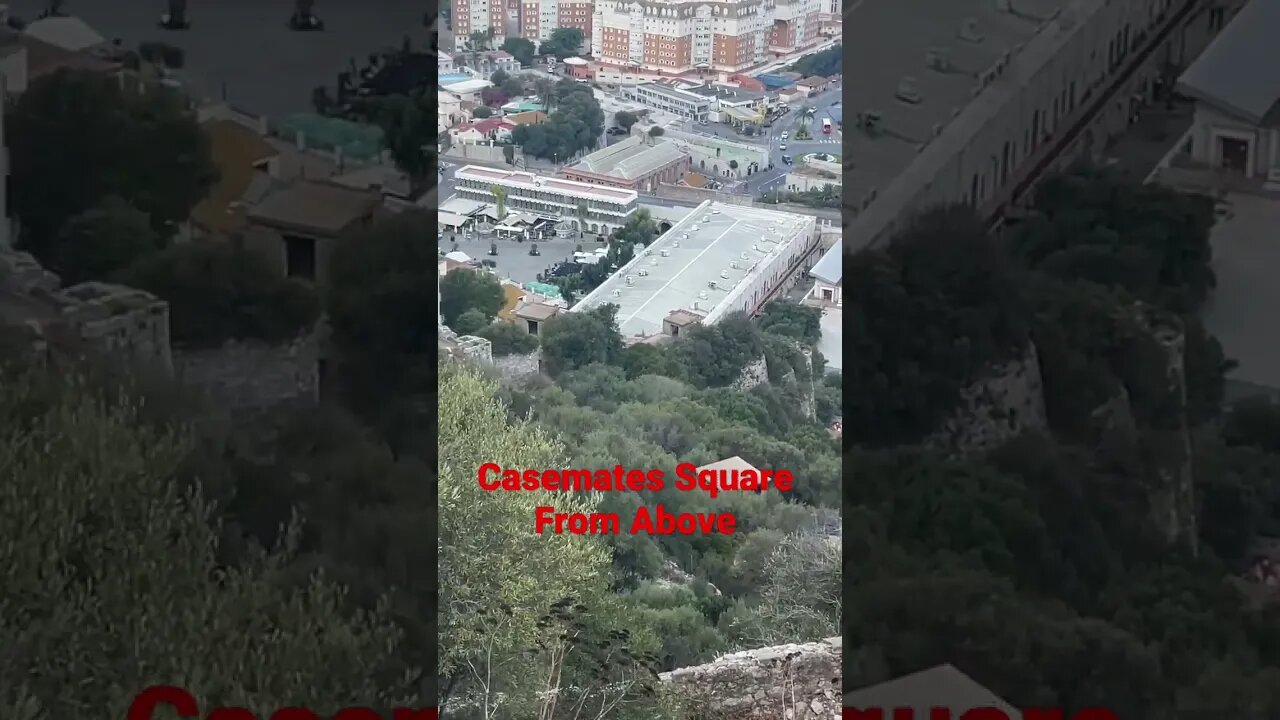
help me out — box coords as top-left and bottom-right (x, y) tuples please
(0, 373), (413, 719)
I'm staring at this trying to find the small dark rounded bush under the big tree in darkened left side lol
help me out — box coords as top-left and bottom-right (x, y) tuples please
(49, 196), (163, 284)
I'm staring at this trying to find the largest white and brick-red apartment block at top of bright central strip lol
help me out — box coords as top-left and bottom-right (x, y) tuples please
(591, 0), (822, 74)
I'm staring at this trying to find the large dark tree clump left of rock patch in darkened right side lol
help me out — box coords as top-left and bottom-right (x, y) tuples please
(844, 209), (1029, 445)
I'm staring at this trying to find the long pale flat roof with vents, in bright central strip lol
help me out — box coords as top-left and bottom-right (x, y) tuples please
(572, 200), (817, 337)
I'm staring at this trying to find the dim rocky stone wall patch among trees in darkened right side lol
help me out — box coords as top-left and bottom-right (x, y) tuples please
(925, 343), (1048, 452)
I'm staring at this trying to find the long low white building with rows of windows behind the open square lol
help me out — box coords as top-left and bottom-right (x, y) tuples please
(454, 165), (640, 232)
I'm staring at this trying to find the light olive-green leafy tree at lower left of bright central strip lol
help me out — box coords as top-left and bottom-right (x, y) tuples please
(438, 365), (629, 717)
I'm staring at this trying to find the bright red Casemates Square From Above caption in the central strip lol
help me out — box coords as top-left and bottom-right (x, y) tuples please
(476, 462), (795, 536)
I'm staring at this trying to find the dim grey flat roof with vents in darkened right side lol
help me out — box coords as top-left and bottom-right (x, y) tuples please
(842, 0), (1070, 243)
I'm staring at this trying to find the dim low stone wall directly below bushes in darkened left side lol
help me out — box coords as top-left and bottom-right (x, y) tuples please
(173, 333), (320, 410)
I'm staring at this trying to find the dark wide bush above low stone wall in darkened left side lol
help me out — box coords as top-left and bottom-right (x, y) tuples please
(118, 240), (320, 348)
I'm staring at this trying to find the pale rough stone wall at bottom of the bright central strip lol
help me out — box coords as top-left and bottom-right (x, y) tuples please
(660, 638), (844, 720)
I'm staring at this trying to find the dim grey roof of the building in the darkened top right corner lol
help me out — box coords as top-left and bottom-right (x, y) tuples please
(1178, 0), (1280, 126)
